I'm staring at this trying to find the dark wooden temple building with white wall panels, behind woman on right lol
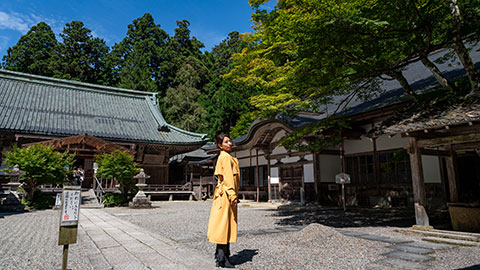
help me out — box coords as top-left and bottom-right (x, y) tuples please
(216, 47), (480, 229)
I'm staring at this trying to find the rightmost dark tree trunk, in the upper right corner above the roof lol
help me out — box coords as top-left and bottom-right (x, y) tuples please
(450, 0), (480, 94)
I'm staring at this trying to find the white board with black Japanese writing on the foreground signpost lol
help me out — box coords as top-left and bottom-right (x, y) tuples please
(60, 186), (81, 226)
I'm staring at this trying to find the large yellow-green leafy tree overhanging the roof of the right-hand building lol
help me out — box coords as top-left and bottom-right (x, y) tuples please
(227, 0), (479, 148)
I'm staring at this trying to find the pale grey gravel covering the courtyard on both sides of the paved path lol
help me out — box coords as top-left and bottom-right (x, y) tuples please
(0, 201), (480, 270)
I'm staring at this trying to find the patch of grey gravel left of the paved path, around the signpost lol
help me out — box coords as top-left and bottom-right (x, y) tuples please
(0, 210), (93, 270)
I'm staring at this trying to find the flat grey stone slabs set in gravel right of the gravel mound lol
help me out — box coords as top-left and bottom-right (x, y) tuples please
(338, 230), (454, 270)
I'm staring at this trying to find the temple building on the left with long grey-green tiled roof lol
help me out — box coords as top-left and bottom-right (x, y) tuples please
(0, 70), (206, 188)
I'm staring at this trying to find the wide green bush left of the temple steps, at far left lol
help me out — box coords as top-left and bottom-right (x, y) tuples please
(5, 144), (75, 201)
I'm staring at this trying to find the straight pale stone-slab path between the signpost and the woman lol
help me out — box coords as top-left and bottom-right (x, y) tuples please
(78, 209), (215, 270)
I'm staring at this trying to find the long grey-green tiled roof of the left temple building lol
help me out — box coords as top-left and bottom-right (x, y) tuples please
(0, 70), (206, 145)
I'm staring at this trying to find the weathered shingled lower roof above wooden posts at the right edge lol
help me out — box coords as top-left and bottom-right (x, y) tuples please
(370, 98), (480, 136)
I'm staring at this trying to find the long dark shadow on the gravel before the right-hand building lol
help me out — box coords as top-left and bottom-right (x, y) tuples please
(268, 207), (450, 229)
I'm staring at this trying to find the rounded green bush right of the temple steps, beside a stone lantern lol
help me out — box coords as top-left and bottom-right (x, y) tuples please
(95, 150), (139, 195)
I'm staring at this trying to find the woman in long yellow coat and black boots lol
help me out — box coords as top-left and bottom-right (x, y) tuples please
(208, 134), (240, 268)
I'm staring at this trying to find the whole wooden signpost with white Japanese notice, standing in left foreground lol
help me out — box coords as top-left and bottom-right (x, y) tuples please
(58, 186), (81, 270)
